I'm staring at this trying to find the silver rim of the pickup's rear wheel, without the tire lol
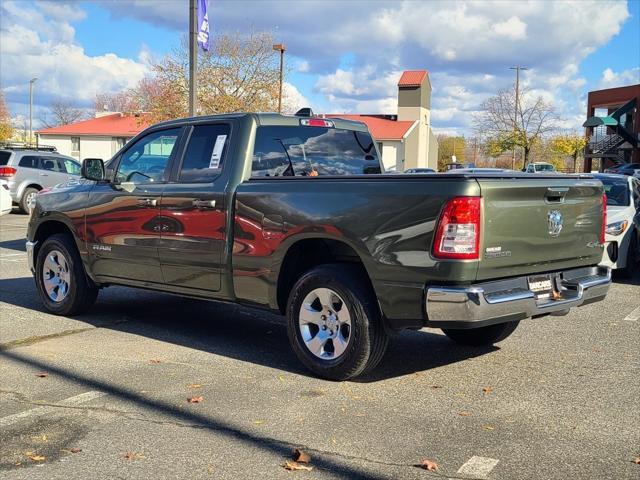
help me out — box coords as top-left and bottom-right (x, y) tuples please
(298, 288), (351, 360)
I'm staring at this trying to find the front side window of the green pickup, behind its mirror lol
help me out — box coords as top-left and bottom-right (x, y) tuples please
(115, 128), (182, 184)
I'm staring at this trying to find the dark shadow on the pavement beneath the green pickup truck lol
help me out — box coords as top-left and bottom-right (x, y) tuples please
(0, 277), (497, 382)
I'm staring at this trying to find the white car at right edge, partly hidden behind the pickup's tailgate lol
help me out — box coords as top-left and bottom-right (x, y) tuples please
(594, 173), (640, 276)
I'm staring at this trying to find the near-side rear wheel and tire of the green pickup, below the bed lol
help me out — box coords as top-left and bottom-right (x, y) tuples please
(287, 264), (389, 381)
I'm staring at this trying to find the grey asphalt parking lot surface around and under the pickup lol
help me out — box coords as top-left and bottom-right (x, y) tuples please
(0, 213), (640, 480)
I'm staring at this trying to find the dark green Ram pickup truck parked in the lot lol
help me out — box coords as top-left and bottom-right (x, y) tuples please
(26, 113), (611, 380)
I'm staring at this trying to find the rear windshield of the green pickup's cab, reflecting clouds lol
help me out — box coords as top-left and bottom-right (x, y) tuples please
(252, 126), (380, 177)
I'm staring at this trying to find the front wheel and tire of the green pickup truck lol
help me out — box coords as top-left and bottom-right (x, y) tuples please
(35, 233), (98, 316)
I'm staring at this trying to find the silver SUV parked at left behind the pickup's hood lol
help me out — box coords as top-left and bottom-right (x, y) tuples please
(0, 144), (80, 213)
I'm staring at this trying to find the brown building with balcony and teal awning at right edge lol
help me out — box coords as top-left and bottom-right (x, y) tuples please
(582, 84), (640, 172)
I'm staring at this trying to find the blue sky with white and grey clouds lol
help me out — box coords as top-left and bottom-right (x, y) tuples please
(0, 0), (640, 135)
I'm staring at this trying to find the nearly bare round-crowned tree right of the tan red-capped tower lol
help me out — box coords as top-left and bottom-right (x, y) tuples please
(474, 89), (559, 165)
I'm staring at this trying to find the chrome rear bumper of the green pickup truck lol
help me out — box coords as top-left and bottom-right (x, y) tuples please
(425, 266), (611, 328)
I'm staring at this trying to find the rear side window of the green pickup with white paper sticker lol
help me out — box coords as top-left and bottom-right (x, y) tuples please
(178, 123), (231, 182)
